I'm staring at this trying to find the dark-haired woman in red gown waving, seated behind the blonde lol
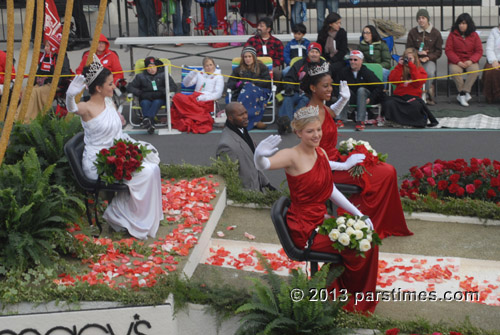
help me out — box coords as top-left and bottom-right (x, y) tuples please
(301, 71), (413, 242)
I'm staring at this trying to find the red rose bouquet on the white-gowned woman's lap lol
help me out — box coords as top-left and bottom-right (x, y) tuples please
(94, 139), (151, 184)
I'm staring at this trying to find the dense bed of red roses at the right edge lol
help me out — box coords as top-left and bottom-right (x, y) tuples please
(399, 158), (500, 203)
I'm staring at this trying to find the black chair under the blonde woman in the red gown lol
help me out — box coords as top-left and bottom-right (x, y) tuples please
(271, 197), (342, 275)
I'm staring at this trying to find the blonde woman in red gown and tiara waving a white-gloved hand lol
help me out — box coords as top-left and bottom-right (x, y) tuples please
(254, 107), (378, 312)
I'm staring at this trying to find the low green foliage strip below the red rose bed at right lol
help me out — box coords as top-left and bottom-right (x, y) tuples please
(401, 195), (500, 220)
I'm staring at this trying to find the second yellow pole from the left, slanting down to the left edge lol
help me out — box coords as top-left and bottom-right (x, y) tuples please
(0, 0), (35, 165)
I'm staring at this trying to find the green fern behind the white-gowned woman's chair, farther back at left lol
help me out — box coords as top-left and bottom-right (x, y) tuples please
(4, 113), (82, 191)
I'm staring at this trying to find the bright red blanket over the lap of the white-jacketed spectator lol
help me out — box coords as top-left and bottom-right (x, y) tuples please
(170, 92), (214, 134)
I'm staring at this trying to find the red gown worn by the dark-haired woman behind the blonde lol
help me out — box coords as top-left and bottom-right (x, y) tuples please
(320, 107), (413, 238)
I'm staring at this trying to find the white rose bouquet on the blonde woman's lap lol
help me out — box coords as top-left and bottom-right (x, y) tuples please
(319, 214), (382, 257)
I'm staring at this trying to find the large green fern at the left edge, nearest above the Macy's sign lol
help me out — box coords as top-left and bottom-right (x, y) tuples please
(0, 148), (83, 269)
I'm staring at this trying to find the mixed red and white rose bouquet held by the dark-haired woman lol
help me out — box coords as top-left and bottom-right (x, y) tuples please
(339, 138), (388, 177)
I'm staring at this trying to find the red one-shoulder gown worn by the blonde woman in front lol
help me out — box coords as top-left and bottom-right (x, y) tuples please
(286, 148), (378, 312)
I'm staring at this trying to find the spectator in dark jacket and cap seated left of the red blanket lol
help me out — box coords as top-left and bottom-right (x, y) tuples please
(127, 57), (177, 134)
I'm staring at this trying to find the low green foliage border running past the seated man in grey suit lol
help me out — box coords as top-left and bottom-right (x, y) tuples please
(160, 158), (289, 206)
